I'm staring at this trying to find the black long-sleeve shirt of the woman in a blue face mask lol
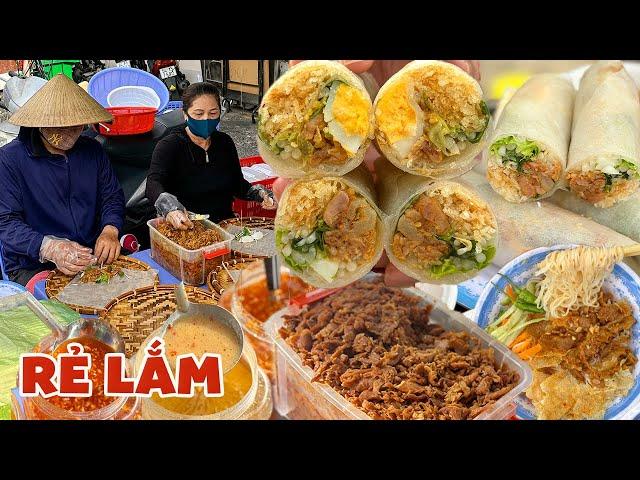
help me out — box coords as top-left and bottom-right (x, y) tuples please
(146, 126), (251, 222)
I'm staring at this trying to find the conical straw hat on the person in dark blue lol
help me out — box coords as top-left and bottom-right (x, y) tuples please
(9, 74), (113, 127)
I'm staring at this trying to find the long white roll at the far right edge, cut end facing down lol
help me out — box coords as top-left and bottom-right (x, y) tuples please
(566, 61), (640, 208)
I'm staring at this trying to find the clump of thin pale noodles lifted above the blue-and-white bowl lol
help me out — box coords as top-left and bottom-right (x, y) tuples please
(536, 246), (624, 318)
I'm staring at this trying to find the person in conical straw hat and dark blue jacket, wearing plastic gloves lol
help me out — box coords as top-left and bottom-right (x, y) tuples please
(0, 75), (125, 285)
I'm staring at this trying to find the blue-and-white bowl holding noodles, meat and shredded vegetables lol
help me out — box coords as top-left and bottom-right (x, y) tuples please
(474, 245), (640, 420)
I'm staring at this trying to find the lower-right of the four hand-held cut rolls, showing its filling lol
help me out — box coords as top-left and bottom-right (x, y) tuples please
(375, 158), (498, 284)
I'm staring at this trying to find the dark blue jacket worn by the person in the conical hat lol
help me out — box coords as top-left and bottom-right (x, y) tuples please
(0, 127), (125, 272)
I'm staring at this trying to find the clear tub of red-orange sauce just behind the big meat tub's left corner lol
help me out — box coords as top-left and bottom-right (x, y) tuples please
(231, 262), (313, 384)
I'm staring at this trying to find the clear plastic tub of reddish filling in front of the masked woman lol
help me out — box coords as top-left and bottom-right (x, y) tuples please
(147, 218), (233, 285)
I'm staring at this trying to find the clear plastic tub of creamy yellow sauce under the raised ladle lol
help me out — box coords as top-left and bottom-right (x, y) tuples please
(132, 329), (273, 420)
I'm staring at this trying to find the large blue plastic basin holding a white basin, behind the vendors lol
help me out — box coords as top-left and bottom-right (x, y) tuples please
(87, 67), (169, 112)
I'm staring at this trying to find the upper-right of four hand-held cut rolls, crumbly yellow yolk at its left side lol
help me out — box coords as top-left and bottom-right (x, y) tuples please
(373, 60), (491, 178)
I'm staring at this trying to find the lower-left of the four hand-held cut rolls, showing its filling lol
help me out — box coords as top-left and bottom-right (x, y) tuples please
(275, 165), (383, 288)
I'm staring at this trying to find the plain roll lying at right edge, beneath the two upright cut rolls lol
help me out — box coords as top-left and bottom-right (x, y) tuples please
(548, 190), (640, 242)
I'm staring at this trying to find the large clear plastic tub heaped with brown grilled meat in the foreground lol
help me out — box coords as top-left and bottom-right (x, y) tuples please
(265, 274), (532, 420)
